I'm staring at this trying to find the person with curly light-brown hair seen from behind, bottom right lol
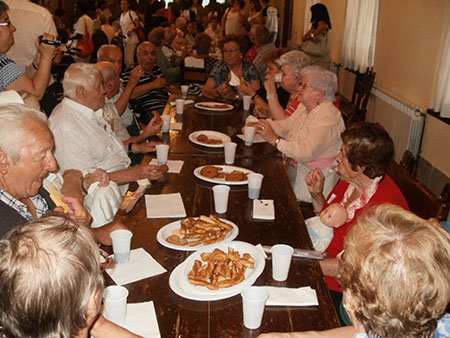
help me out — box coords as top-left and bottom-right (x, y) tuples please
(260, 204), (450, 338)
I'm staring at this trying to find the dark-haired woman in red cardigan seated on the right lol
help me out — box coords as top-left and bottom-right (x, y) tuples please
(306, 122), (408, 312)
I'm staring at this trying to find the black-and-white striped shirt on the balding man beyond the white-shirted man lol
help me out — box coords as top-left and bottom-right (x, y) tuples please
(121, 65), (169, 124)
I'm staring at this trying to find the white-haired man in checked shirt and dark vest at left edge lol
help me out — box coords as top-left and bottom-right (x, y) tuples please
(0, 104), (124, 244)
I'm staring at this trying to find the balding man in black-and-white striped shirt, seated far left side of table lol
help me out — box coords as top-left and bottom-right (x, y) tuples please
(122, 41), (169, 124)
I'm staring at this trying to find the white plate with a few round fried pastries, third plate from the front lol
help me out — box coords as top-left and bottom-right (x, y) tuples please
(194, 165), (253, 185)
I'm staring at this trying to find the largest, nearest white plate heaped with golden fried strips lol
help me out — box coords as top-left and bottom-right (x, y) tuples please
(169, 241), (266, 301)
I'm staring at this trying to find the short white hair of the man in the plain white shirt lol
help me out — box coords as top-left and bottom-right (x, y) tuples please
(62, 62), (103, 99)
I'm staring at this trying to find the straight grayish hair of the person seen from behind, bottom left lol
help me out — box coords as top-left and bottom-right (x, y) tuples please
(0, 215), (103, 337)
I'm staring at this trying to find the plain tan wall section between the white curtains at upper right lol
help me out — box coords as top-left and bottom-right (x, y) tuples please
(375, 0), (449, 109)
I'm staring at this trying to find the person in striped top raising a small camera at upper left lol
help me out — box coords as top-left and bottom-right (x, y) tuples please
(0, 1), (55, 100)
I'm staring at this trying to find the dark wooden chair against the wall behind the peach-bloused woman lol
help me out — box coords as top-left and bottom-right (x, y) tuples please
(340, 68), (375, 126)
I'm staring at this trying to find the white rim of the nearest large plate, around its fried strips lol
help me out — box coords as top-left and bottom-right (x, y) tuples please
(169, 241), (266, 301)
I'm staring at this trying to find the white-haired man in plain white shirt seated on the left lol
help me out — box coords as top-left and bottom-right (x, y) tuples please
(49, 63), (161, 194)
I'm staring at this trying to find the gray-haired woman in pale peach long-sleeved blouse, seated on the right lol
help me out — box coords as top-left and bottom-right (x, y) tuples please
(256, 66), (345, 202)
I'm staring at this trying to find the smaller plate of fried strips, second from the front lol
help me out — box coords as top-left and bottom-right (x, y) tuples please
(156, 215), (239, 251)
